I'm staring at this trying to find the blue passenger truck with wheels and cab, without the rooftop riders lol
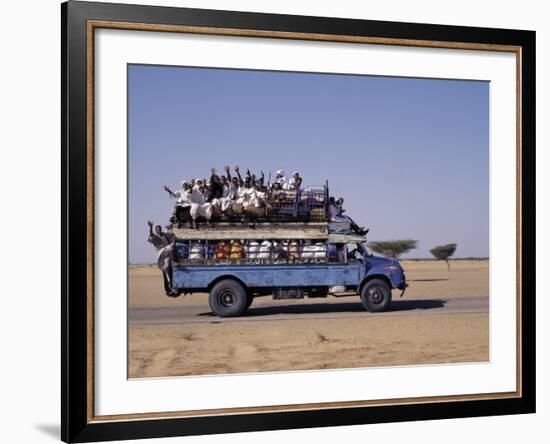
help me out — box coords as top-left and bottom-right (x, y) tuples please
(171, 222), (407, 317)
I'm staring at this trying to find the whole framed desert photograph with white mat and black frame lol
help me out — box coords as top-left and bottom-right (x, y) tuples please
(61, 1), (535, 442)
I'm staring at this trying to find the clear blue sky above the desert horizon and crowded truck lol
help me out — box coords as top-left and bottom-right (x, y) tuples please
(128, 65), (489, 263)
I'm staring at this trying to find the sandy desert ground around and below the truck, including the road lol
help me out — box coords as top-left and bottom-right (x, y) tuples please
(128, 261), (489, 378)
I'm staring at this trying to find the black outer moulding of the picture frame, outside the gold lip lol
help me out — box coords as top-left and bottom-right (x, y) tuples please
(61, 1), (536, 442)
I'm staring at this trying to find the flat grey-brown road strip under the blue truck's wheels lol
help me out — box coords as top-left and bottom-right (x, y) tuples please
(128, 296), (489, 325)
